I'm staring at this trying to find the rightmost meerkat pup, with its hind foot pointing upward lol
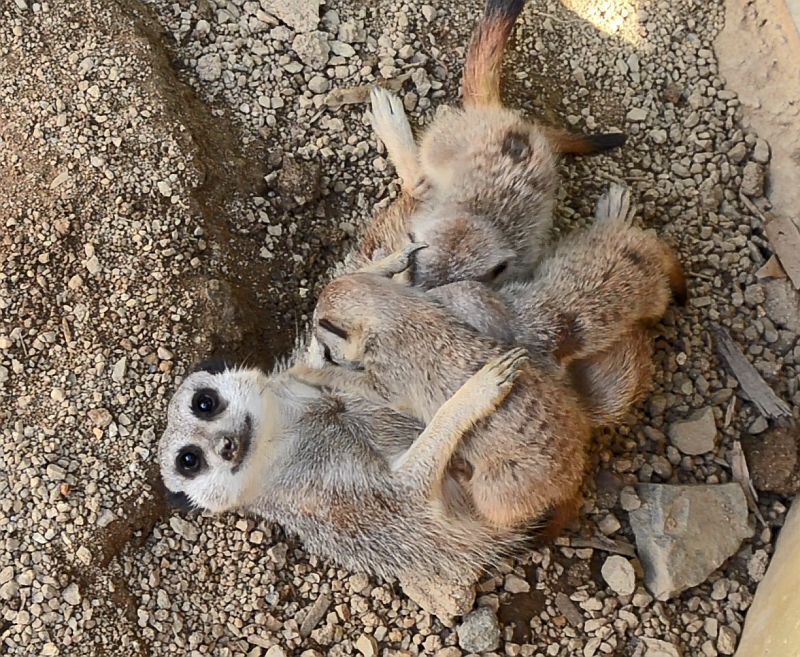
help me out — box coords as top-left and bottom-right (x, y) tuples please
(418, 185), (687, 426)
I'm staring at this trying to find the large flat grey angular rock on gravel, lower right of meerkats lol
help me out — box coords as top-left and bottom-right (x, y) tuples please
(630, 483), (753, 600)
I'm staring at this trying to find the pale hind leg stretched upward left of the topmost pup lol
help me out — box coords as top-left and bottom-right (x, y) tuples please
(370, 86), (421, 192)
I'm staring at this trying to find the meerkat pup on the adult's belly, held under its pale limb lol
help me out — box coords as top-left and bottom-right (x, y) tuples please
(292, 245), (591, 529)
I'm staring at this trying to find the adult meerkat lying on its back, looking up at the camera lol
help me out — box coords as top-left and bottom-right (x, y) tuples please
(158, 349), (527, 584)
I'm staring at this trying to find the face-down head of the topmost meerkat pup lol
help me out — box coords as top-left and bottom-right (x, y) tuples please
(411, 214), (517, 288)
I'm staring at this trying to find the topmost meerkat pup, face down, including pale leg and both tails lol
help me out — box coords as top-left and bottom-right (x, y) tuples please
(371, 0), (624, 287)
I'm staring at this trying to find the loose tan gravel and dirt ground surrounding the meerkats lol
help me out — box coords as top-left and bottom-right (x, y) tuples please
(0, 0), (800, 657)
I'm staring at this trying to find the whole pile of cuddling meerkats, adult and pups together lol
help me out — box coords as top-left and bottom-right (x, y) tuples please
(159, 0), (686, 583)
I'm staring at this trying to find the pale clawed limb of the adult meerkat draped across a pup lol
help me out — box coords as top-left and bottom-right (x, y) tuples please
(393, 347), (528, 490)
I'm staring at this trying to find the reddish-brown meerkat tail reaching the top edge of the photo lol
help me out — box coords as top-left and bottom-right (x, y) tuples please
(462, 0), (525, 106)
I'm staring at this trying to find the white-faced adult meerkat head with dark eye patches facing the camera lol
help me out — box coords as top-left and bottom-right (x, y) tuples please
(158, 364), (269, 512)
